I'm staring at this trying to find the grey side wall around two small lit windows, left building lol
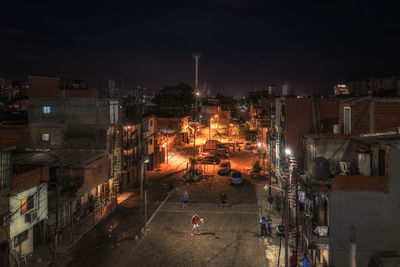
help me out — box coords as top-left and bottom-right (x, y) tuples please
(28, 97), (110, 149)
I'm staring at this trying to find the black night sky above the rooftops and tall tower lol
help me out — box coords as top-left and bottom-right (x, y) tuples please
(0, 0), (400, 95)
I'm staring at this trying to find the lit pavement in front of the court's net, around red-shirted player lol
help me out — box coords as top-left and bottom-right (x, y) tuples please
(96, 212), (268, 266)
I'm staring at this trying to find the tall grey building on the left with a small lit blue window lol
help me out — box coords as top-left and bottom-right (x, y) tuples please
(28, 75), (123, 193)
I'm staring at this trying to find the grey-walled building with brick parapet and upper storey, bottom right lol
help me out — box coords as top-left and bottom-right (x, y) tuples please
(329, 135), (400, 266)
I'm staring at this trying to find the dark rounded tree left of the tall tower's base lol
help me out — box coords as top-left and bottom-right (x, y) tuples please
(154, 83), (194, 108)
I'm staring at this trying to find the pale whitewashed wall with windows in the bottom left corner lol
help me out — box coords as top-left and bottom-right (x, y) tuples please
(10, 183), (47, 254)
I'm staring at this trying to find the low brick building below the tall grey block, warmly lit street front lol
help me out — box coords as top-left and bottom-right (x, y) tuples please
(14, 150), (118, 245)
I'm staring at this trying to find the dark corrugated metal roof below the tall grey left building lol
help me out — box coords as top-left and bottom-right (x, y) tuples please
(13, 150), (107, 168)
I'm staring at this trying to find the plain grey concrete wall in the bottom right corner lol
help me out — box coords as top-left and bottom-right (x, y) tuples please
(329, 149), (400, 267)
